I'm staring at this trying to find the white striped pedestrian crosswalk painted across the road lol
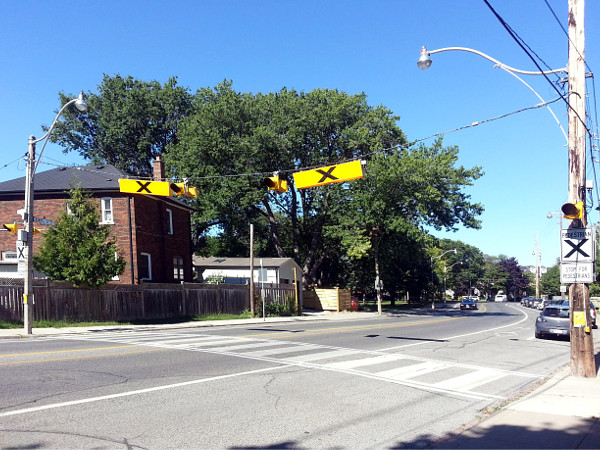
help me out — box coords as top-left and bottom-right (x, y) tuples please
(53, 331), (543, 400)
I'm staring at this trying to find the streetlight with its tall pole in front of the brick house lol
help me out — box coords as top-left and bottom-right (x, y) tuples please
(22, 92), (87, 334)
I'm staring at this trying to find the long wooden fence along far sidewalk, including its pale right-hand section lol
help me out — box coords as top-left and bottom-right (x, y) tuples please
(0, 280), (295, 322)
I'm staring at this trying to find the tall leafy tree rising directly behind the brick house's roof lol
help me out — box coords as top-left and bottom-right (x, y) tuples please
(51, 75), (192, 176)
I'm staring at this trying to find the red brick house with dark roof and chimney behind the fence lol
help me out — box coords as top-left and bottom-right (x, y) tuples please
(0, 158), (193, 284)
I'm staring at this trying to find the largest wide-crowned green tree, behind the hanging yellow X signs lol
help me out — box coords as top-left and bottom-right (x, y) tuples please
(165, 82), (403, 284)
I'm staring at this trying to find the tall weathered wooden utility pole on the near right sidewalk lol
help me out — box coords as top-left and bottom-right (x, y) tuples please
(567, 0), (596, 377)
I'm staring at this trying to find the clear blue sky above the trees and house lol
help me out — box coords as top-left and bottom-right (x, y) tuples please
(0, 0), (600, 265)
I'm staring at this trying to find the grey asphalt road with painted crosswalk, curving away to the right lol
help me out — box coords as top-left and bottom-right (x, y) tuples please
(0, 303), (569, 448)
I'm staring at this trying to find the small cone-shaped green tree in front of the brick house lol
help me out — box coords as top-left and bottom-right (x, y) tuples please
(33, 186), (125, 288)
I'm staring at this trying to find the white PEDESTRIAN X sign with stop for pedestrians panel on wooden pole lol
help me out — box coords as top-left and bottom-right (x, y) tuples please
(560, 228), (596, 284)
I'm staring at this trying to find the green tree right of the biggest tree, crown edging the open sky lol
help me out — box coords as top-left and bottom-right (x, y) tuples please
(339, 139), (483, 312)
